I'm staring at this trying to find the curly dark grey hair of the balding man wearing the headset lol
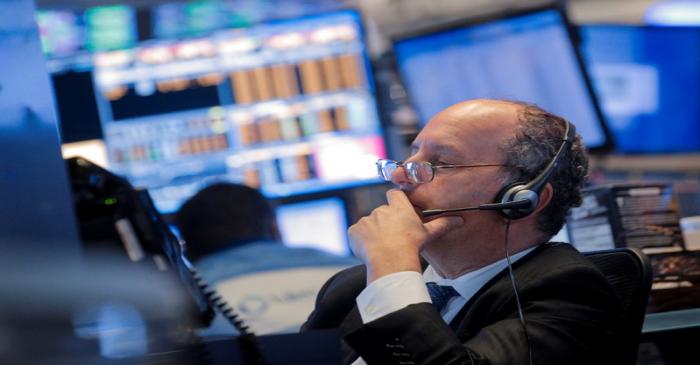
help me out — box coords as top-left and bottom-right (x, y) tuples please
(502, 102), (588, 237)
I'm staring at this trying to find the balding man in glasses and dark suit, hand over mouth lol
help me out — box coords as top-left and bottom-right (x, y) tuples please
(303, 100), (621, 364)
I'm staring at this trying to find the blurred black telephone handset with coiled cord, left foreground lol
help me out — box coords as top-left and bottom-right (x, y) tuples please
(66, 157), (264, 364)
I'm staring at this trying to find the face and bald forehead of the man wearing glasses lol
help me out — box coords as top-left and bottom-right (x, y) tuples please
(393, 100), (517, 228)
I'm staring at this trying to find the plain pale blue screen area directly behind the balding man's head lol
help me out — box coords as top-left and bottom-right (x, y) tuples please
(394, 9), (608, 149)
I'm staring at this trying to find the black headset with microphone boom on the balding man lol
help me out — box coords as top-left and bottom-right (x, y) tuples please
(421, 120), (576, 220)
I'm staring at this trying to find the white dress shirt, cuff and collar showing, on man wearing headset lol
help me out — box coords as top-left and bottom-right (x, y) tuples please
(353, 247), (535, 365)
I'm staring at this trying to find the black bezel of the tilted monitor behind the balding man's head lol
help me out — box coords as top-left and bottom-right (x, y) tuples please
(391, 4), (615, 155)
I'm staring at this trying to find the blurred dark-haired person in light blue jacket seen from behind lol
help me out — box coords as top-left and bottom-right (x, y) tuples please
(176, 184), (357, 336)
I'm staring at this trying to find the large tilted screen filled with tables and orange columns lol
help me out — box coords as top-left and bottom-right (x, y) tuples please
(77, 11), (386, 213)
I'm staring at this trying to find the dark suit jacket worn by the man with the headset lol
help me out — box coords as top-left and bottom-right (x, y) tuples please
(302, 244), (621, 365)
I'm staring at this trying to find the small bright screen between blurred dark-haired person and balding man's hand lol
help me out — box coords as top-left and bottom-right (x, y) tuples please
(277, 198), (350, 256)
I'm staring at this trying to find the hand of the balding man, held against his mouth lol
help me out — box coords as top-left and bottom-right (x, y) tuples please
(348, 189), (464, 283)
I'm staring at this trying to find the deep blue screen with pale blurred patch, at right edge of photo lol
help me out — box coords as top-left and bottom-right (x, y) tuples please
(581, 25), (700, 153)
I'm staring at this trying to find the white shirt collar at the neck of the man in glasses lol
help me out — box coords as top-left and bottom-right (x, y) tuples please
(423, 246), (537, 300)
